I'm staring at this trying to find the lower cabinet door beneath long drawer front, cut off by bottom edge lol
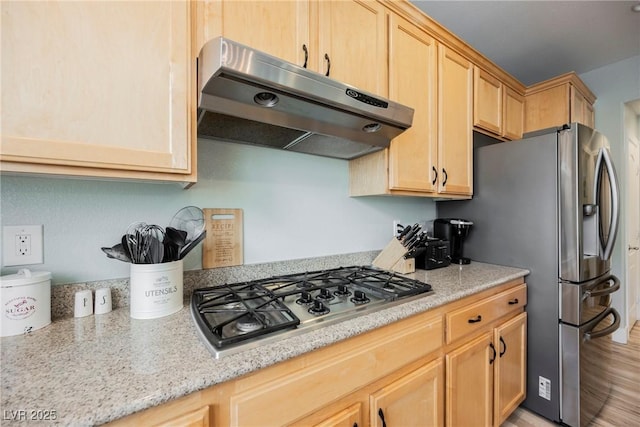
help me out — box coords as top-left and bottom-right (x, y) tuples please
(369, 359), (444, 427)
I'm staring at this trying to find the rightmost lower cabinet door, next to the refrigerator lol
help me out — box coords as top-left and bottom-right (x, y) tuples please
(493, 313), (527, 427)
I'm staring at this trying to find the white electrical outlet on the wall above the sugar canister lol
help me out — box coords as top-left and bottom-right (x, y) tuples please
(2, 225), (44, 267)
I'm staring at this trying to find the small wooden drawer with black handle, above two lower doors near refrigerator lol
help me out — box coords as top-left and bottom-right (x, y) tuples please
(445, 284), (527, 344)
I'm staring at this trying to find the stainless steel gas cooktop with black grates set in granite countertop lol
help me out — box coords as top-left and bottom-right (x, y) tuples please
(191, 267), (432, 358)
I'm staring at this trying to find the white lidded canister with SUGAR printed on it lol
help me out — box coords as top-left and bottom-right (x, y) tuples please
(0, 268), (51, 337)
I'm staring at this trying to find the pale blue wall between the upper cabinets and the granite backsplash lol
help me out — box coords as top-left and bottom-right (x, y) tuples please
(0, 140), (435, 283)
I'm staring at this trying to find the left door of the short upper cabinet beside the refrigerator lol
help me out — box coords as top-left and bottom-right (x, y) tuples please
(473, 67), (503, 135)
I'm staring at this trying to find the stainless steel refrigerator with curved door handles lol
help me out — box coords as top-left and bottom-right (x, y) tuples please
(437, 123), (620, 426)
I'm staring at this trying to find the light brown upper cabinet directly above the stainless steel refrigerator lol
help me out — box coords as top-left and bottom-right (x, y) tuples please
(525, 72), (596, 132)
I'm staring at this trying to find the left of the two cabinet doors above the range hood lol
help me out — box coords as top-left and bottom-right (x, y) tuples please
(203, 0), (311, 66)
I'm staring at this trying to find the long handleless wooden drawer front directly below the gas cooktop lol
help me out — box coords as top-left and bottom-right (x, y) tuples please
(230, 315), (443, 426)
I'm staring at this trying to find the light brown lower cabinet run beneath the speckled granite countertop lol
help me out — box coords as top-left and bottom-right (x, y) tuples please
(105, 279), (526, 427)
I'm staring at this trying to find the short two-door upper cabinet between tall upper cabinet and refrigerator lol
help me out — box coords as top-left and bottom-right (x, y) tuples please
(473, 66), (524, 139)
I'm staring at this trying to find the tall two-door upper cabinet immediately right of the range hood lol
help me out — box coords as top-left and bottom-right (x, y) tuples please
(349, 19), (473, 198)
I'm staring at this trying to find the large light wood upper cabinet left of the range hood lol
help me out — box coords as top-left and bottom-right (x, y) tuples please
(0, 1), (196, 182)
